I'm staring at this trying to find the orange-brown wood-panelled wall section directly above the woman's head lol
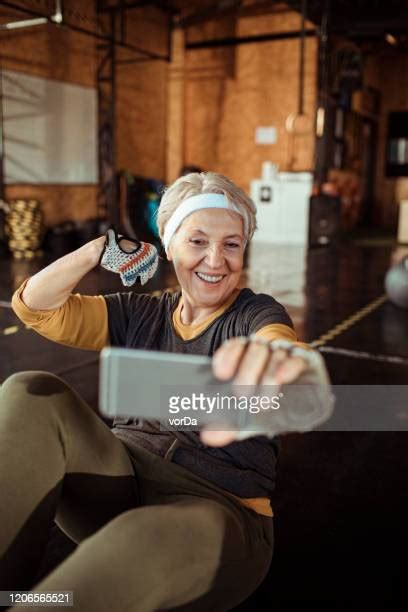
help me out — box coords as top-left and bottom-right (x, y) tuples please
(174, 12), (317, 190)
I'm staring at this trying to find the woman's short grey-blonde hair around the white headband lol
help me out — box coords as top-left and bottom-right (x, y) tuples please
(157, 172), (256, 243)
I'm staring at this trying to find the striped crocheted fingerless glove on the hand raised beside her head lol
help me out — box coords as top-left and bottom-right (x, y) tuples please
(100, 229), (159, 287)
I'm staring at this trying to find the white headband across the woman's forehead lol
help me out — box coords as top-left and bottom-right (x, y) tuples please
(163, 193), (246, 251)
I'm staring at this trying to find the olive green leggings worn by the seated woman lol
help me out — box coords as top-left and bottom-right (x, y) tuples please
(0, 372), (273, 612)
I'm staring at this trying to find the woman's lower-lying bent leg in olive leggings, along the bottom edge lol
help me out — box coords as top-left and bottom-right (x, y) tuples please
(18, 497), (272, 612)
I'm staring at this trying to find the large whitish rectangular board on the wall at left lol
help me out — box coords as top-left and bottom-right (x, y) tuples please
(2, 70), (98, 184)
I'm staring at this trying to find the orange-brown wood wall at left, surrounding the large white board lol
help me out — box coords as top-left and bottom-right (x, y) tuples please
(0, 0), (167, 225)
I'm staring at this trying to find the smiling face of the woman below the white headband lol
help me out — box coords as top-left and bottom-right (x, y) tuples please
(168, 208), (245, 308)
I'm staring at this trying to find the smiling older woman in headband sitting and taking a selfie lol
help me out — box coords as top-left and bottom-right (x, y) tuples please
(0, 172), (332, 612)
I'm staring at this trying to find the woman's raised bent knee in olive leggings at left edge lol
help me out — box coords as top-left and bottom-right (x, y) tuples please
(0, 372), (138, 590)
